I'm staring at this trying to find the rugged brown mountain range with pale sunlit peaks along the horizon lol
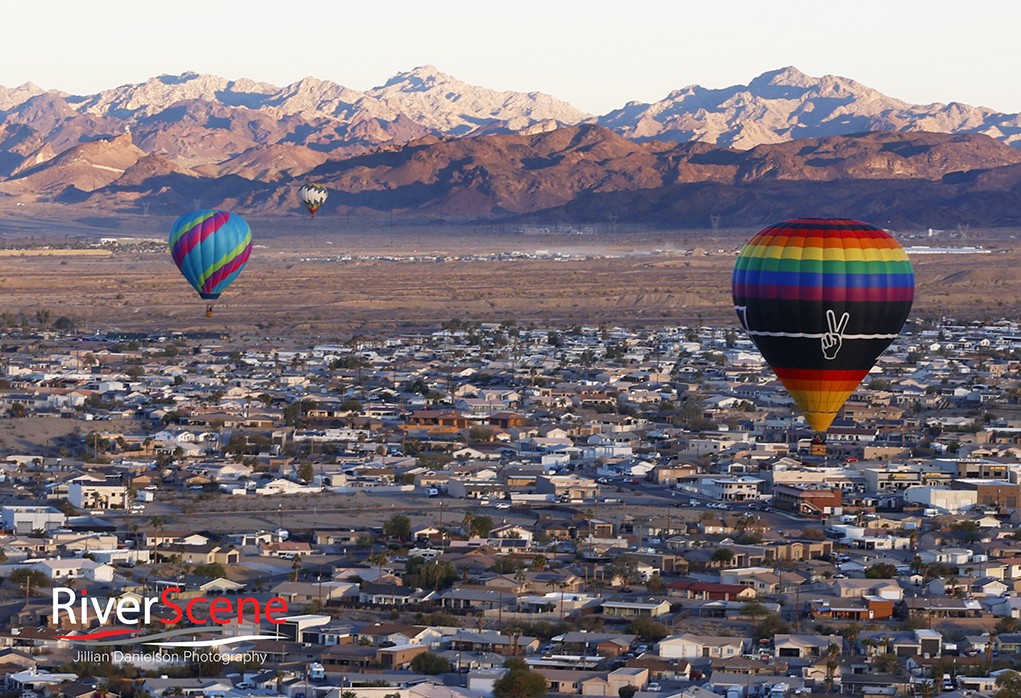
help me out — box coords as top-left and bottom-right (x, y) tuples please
(0, 66), (1021, 227)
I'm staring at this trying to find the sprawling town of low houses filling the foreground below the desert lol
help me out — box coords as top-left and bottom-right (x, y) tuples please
(0, 311), (1021, 698)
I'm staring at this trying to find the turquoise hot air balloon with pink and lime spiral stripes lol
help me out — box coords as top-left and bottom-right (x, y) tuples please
(171, 211), (252, 316)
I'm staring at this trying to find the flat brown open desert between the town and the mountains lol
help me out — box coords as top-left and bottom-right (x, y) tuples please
(0, 211), (1021, 337)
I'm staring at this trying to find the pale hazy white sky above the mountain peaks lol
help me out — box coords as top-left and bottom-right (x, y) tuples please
(7, 0), (1021, 113)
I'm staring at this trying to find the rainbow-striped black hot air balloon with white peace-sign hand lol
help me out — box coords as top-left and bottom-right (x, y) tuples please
(732, 218), (915, 433)
